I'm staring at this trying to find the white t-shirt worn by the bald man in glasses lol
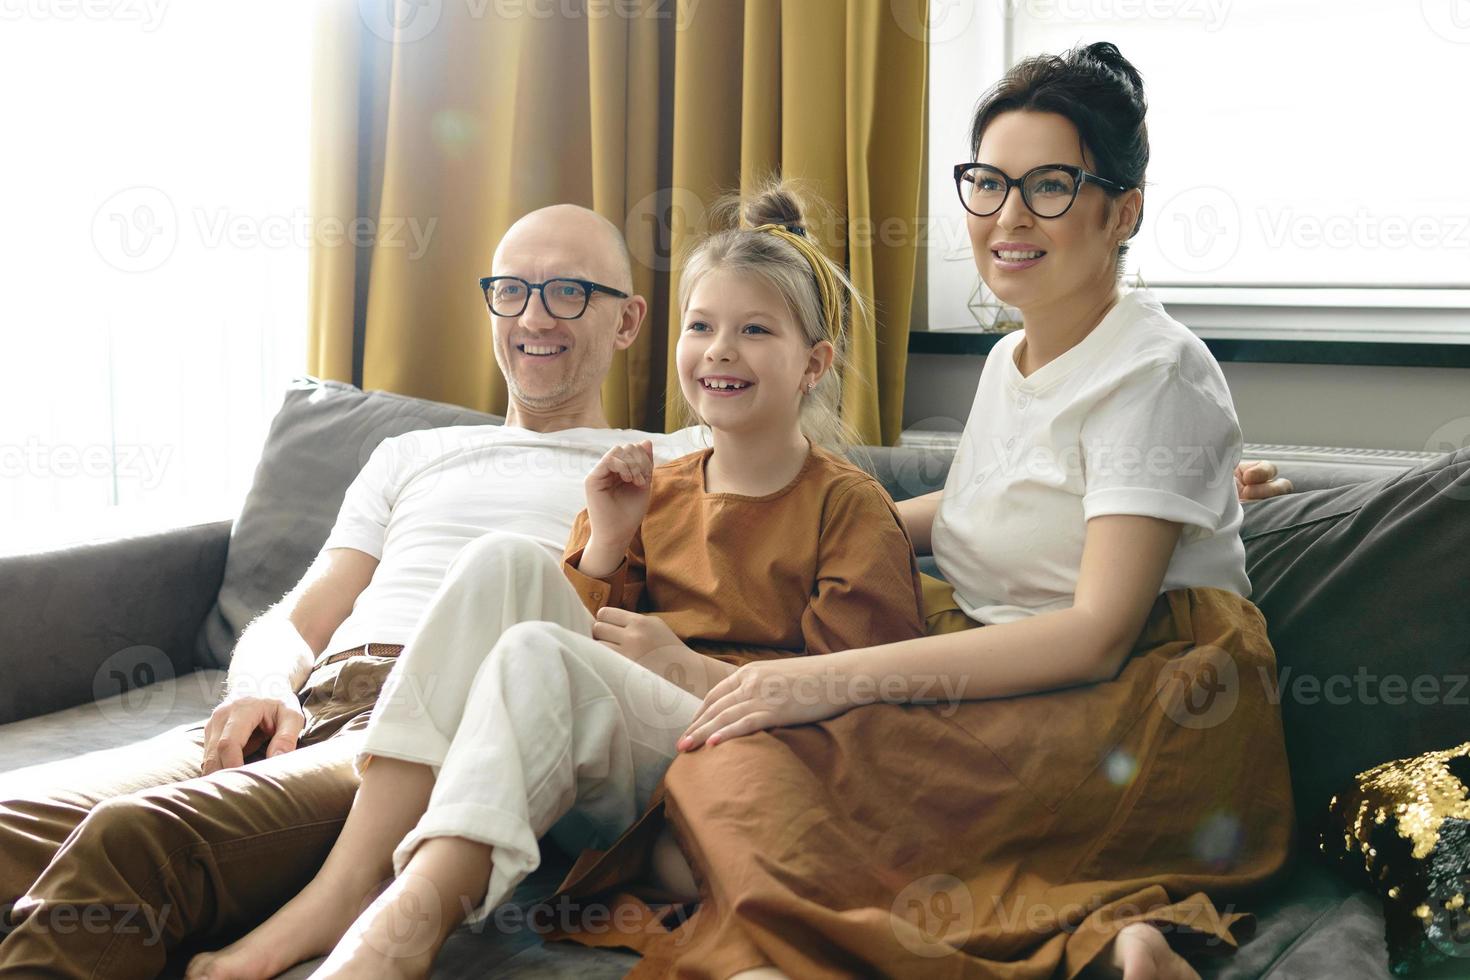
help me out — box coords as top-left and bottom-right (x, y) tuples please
(322, 425), (709, 652)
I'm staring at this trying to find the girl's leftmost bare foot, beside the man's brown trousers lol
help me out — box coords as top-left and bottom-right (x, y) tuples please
(184, 880), (376, 980)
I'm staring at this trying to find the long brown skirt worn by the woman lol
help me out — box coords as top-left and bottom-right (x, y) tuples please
(547, 580), (1292, 980)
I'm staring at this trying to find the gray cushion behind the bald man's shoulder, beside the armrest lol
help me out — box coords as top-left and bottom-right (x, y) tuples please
(197, 378), (504, 667)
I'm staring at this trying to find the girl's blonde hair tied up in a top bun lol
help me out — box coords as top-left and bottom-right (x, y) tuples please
(676, 179), (867, 453)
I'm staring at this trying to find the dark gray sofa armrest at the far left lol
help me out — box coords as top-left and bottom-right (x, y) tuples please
(0, 520), (231, 724)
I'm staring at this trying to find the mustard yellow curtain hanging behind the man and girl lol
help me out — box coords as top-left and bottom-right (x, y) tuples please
(309, 0), (928, 444)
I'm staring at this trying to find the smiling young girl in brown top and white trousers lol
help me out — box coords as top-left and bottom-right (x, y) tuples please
(190, 187), (923, 977)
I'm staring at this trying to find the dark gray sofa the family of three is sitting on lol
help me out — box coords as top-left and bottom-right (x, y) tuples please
(0, 379), (1470, 980)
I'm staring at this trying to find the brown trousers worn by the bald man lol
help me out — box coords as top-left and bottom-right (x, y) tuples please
(0, 644), (401, 980)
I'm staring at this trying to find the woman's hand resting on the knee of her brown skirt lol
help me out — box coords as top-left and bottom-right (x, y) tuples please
(678, 657), (854, 752)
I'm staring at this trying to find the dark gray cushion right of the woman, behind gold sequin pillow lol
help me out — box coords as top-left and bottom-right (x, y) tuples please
(1241, 450), (1470, 846)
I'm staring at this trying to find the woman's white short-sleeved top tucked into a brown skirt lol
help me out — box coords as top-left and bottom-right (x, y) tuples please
(932, 289), (1251, 623)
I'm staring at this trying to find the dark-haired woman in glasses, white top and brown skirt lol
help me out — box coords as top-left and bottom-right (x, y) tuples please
(546, 43), (1292, 980)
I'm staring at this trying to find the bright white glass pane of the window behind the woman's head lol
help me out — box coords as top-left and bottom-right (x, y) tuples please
(1011, 0), (1470, 288)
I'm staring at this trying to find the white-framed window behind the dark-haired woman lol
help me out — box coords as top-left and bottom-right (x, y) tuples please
(931, 0), (1470, 342)
